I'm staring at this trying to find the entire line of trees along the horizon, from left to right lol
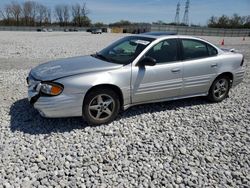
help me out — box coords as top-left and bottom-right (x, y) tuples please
(0, 0), (250, 28)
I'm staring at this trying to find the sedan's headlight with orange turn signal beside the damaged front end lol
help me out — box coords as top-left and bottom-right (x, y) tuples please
(40, 83), (63, 96)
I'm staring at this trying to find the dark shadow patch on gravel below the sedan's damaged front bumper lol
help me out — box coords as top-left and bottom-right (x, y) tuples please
(10, 98), (88, 135)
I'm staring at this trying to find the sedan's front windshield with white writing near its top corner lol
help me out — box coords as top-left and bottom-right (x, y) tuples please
(94, 36), (154, 64)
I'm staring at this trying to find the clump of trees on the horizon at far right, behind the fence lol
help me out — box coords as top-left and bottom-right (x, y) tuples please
(208, 14), (250, 29)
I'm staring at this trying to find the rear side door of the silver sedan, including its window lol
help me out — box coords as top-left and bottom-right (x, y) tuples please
(180, 39), (218, 96)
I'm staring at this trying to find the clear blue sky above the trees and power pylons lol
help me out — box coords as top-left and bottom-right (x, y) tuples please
(0, 0), (250, 25)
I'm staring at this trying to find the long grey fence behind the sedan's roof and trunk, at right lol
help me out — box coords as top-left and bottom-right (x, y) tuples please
(151, 25), (250, 37)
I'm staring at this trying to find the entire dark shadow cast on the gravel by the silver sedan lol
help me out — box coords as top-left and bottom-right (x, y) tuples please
(10, 97), (208, 135)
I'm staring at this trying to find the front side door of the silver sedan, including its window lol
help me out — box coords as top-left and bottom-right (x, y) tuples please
(131, 39), (183, 103)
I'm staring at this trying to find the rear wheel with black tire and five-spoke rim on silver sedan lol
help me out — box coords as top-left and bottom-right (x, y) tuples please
(208, 76), (230, 102)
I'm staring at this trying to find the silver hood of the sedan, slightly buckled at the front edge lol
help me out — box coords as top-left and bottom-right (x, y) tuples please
(31, 56), (123, 81)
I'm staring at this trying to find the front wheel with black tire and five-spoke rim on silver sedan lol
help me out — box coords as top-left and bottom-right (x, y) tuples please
(83, 88), (120, 125)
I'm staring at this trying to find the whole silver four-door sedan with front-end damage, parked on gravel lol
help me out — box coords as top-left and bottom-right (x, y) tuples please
(27, 33), (246, 125)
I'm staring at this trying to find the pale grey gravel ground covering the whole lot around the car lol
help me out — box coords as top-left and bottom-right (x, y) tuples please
(0, 32), (250, 188)
